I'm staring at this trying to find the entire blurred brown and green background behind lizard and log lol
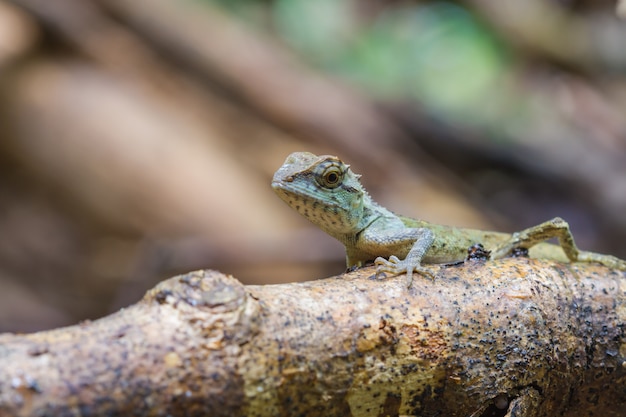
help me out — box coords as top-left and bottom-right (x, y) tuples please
(0, 0), (626, 332)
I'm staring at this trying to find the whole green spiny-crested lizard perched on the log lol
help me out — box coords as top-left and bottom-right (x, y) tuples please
(272, 152), (626, 287)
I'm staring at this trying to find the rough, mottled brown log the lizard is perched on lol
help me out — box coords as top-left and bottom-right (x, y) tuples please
(0, 258), (626, 417)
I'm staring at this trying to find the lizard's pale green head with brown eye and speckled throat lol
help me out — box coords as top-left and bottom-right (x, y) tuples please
(272, 152), (367, 237)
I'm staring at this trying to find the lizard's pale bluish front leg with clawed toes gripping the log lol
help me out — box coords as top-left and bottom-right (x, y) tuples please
(361, 228), (434, 287)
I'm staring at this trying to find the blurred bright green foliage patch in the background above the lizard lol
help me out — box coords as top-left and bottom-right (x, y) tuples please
(204, 0), (532, 138)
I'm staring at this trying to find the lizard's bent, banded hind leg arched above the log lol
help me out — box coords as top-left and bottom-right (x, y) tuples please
(491, 217), (626, 270)
